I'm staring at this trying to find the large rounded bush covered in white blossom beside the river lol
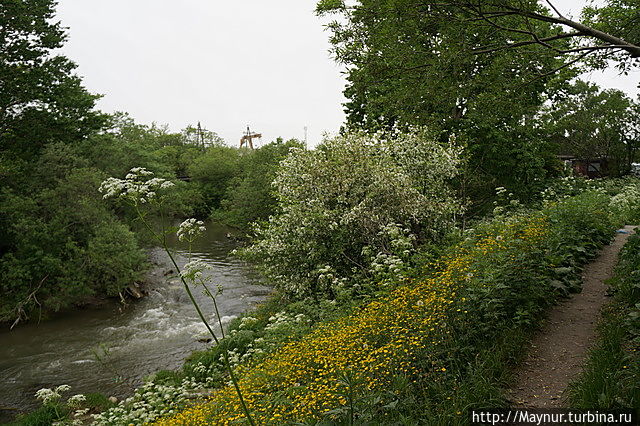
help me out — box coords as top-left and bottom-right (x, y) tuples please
(242, 128), (462, 297)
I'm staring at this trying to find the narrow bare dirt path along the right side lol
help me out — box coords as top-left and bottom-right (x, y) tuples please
(509, 226), (634, 408)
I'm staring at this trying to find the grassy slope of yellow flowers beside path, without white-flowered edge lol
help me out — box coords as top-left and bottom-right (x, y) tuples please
(151, 193), (612, 424)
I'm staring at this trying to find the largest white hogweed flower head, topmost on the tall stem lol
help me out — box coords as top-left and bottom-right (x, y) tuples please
(98, 167), (175, 204)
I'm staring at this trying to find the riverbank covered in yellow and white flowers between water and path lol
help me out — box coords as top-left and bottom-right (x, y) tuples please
(75, 193), (613, 425)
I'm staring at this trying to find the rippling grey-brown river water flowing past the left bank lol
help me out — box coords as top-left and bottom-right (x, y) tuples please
(0, 223), (270, 422)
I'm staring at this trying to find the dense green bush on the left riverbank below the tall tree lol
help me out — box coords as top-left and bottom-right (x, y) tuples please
(0, 164), (144, 321)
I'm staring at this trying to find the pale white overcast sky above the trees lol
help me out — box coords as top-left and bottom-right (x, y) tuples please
(58, 0), (640, 145)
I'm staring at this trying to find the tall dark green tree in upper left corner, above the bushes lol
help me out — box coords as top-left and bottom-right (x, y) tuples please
(0, 0), (103, 166)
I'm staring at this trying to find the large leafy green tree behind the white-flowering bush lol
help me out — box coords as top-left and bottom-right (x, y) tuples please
(318, 0), (574, 203)
